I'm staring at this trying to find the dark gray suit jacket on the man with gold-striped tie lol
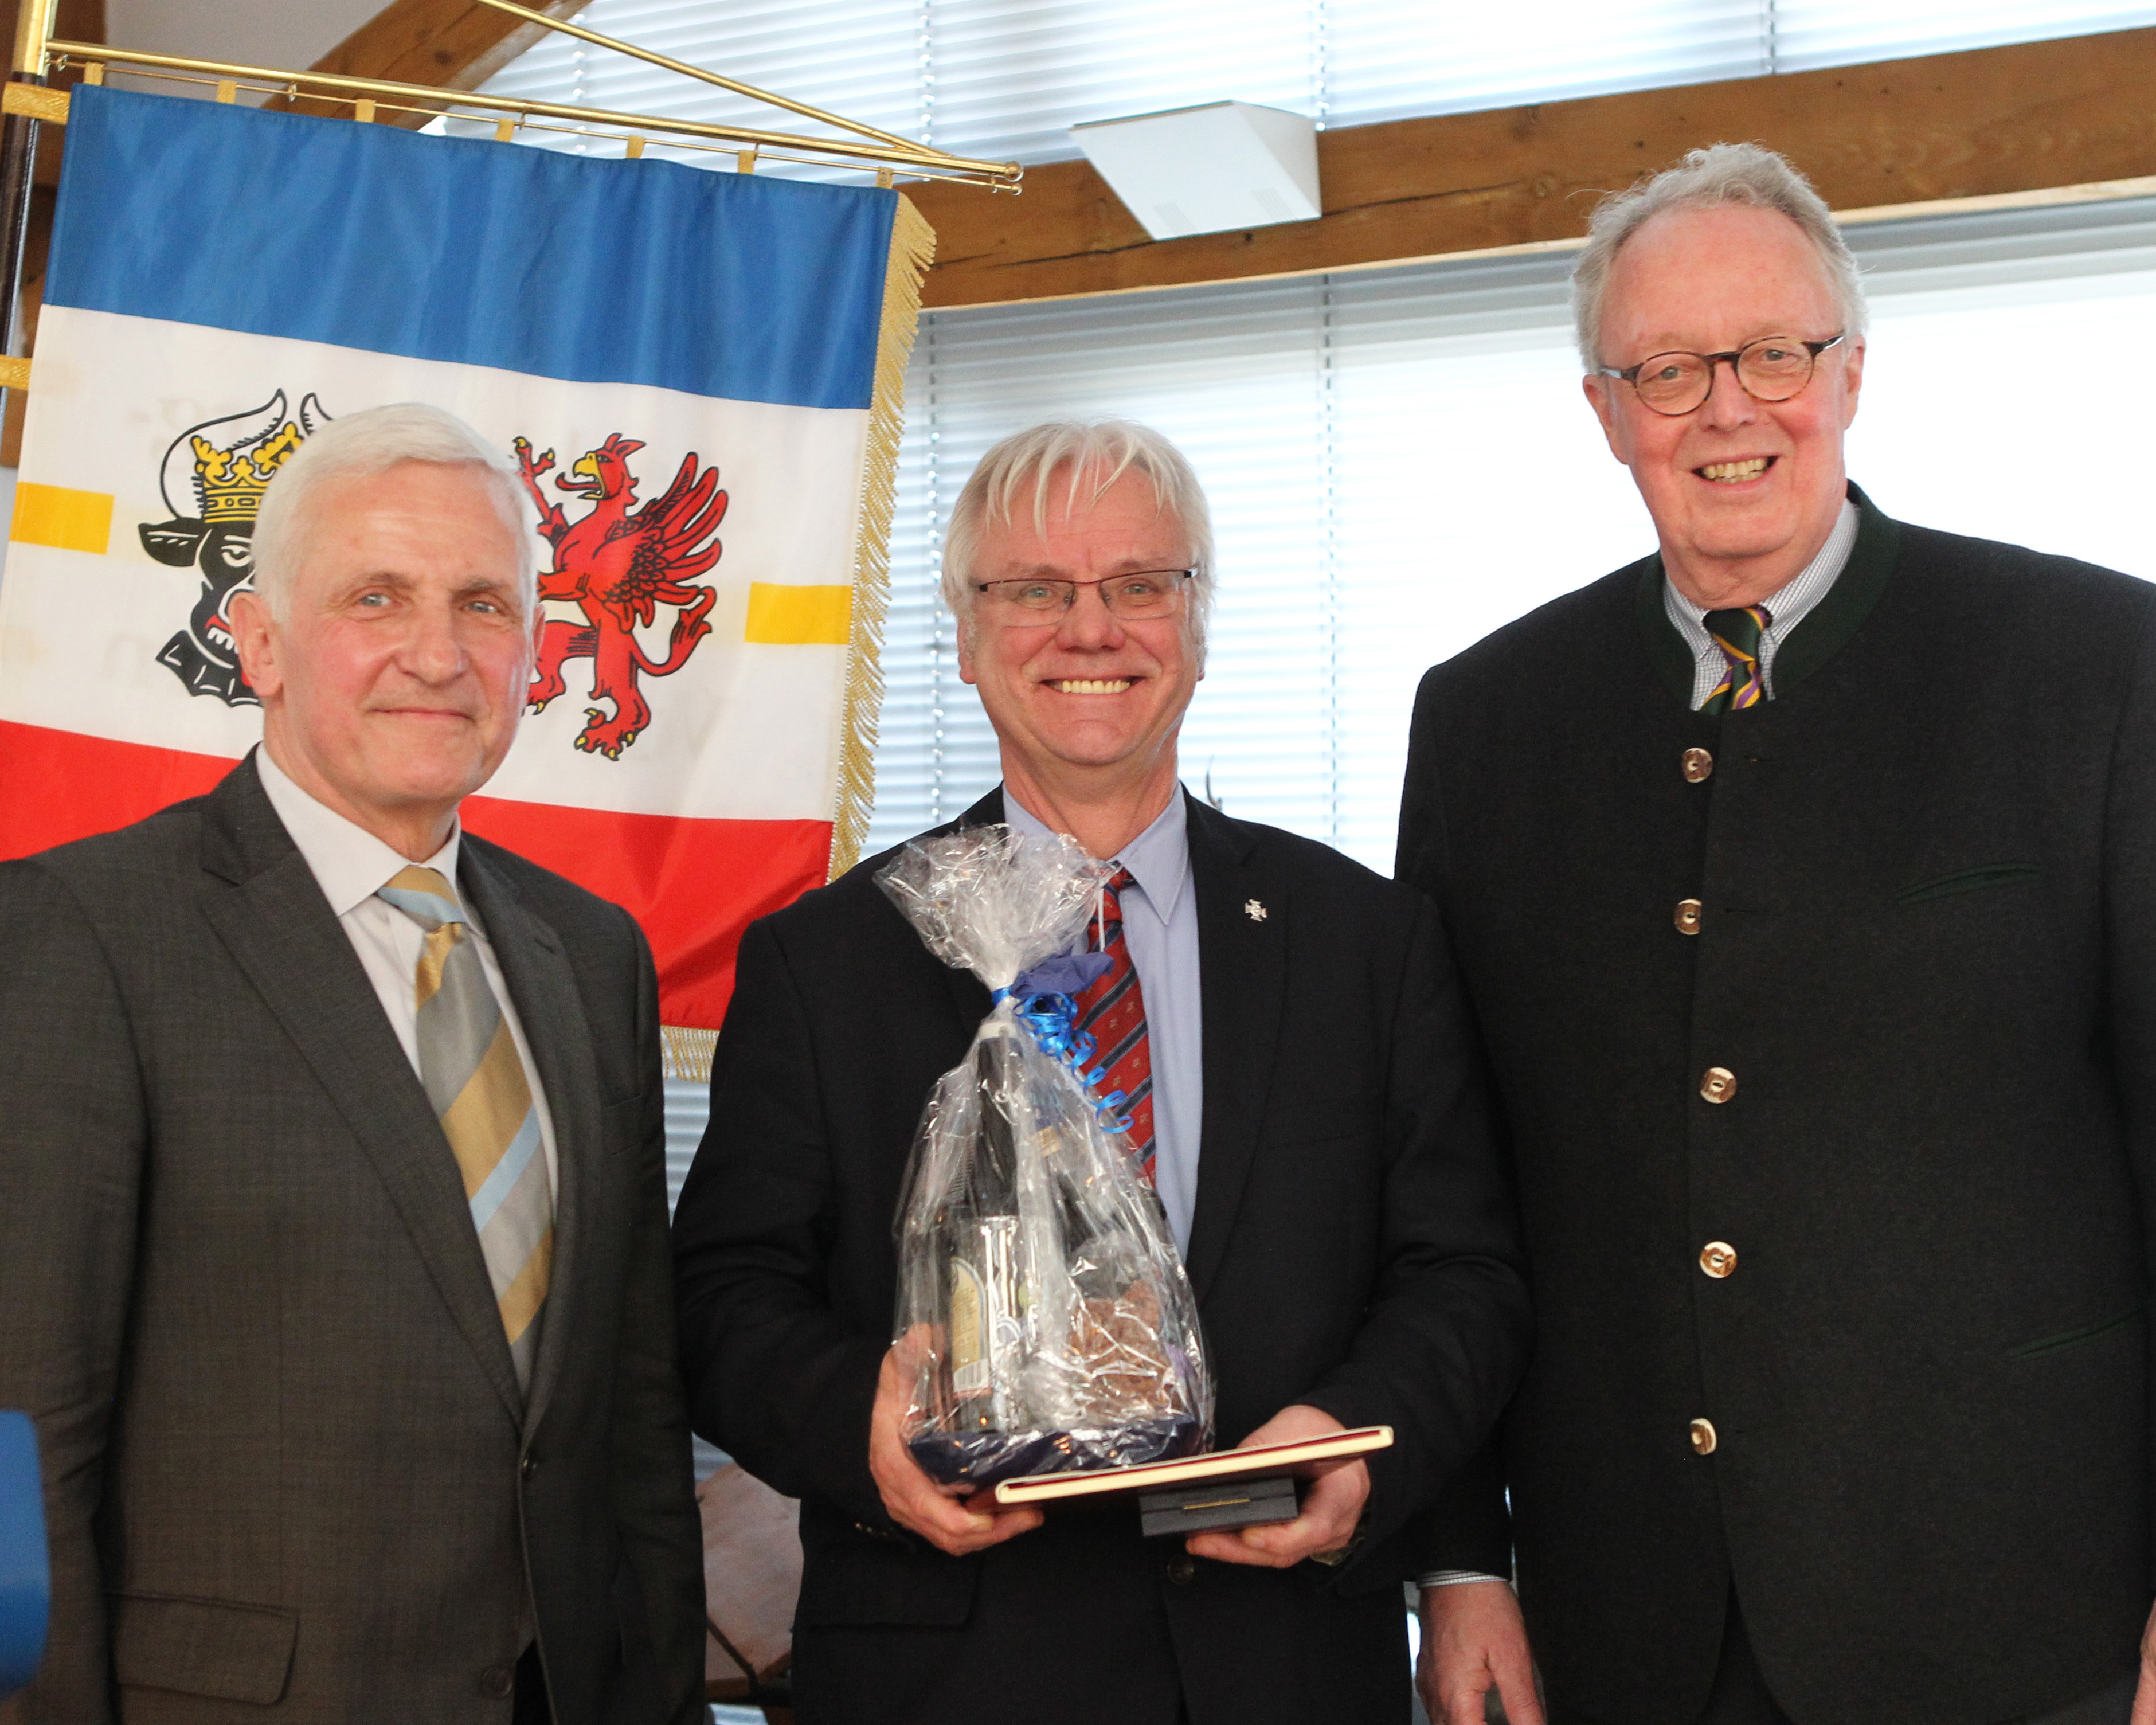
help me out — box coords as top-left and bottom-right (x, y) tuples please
(0, 761), (703, 1725)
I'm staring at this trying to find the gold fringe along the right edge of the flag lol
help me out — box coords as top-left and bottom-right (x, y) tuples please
(664, 194), (936, 1085)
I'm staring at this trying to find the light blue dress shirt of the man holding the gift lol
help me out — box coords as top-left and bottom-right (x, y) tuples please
(1003, 785), (1205, 1257)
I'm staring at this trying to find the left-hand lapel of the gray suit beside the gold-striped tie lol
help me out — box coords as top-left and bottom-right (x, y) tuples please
(203, 759), (522, 1417)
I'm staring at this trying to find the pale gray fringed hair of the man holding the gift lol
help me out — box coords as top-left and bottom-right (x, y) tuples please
(942, 418), (1214, 643)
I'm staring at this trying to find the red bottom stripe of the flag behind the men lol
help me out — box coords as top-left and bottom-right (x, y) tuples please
(0, 720), (830, 1028)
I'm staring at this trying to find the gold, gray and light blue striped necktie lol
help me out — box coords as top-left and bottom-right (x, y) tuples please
(377, 867), (554, 1388)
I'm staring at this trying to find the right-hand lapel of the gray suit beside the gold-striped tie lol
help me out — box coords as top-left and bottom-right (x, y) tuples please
(459, 839), (604, 1431)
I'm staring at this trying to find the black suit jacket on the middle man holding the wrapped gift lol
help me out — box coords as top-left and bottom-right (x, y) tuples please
(675, 793), (1527, 1725)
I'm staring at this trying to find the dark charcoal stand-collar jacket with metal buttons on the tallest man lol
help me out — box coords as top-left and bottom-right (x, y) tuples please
(1402, 485), (2156, 1725)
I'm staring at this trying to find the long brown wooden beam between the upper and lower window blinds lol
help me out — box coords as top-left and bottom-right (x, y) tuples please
(906, 30), (2156, 308)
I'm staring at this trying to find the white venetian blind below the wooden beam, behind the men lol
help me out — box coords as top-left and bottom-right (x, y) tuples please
(871, 201), (2156, 871)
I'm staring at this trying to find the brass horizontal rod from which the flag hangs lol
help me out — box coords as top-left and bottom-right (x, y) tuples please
(41, 37), (1024, 192)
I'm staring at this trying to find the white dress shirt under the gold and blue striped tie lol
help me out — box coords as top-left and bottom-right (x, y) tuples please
(255, 746), (561, 1192)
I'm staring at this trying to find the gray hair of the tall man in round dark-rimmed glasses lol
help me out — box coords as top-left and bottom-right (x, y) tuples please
(1572, 144), (1867, 371)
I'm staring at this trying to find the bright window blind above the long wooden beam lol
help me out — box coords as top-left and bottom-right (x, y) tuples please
(463, 0), (2156, 175)
